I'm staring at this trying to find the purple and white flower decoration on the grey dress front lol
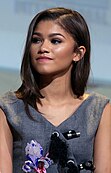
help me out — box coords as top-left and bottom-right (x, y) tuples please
(22, 140), (53, 173)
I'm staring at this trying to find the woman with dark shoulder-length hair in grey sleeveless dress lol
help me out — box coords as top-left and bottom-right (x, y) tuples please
(0, 8), (111, 173)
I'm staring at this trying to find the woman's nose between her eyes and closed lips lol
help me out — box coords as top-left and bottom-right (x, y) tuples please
(39, 40), (50, 53)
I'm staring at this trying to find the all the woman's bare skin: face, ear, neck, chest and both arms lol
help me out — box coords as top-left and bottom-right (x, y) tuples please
(0, 21), (111, 173)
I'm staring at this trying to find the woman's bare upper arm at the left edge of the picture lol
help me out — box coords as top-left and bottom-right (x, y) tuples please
(0, 109), (13, 173)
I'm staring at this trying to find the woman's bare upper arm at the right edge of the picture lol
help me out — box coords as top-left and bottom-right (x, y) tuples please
(94, 103), (111, 173)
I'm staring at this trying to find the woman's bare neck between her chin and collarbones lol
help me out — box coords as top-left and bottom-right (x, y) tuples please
(40, 72), (74, 104)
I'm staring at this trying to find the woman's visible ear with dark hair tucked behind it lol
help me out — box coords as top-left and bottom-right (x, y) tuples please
(73, 46), (86, 62)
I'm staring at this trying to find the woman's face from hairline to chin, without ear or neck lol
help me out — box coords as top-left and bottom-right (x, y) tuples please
(30, 21), (76, 75)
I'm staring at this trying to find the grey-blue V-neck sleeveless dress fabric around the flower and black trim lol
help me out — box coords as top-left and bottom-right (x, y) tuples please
(0, 92), (110, 173)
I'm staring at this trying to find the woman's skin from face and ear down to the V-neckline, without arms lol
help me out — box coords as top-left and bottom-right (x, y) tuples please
(30, 21), (86, 126)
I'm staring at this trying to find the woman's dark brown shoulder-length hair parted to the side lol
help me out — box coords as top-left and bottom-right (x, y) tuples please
(16, 7), (90, 117)
